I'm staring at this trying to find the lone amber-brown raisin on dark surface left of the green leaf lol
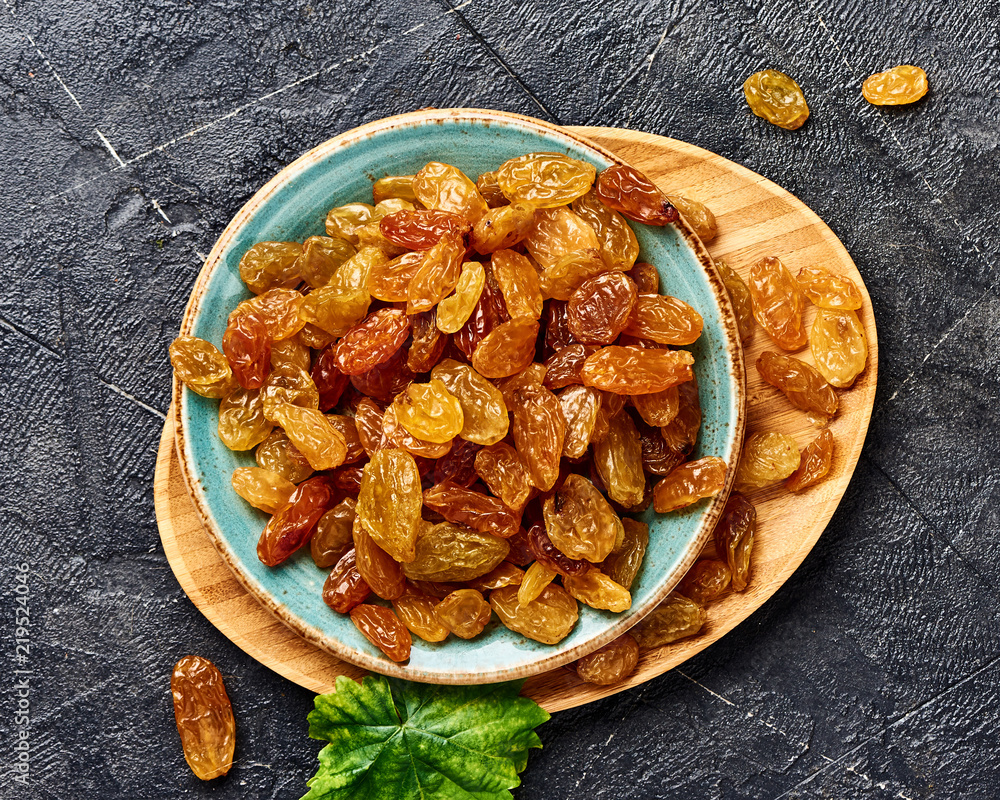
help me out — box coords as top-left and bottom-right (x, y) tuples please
(170, 656), (236, 781)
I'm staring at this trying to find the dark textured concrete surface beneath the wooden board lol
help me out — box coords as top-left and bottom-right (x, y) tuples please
(0, 0), (1000, 800)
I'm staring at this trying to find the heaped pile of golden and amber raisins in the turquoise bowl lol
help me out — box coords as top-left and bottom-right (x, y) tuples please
(170, 153), (736, 682)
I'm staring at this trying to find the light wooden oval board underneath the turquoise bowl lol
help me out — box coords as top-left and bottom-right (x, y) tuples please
(154, 128), (878, 711)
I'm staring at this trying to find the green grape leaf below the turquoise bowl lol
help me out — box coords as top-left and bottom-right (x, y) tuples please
(302, 676), (549, 800)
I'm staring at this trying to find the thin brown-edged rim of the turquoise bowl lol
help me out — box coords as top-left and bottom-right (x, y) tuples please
(172, 109), (746, 684)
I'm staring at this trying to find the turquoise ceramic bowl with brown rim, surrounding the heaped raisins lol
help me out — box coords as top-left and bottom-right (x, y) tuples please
(174, 104), (745, 684)
